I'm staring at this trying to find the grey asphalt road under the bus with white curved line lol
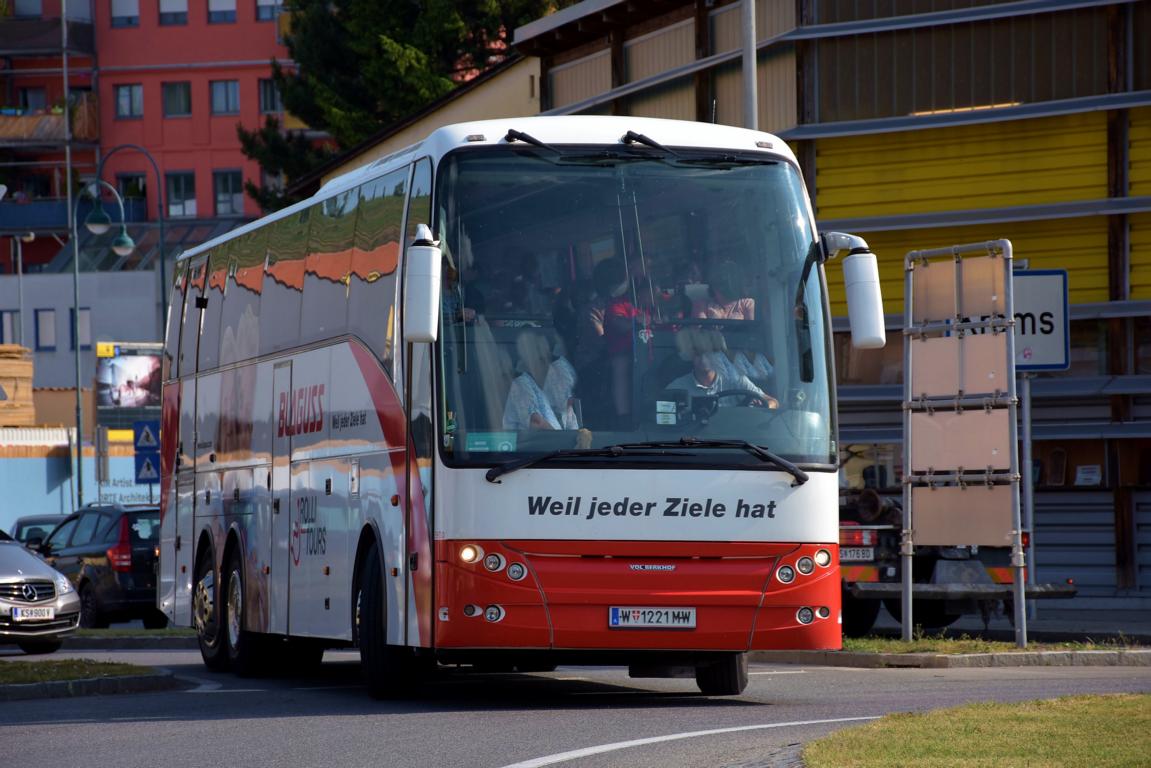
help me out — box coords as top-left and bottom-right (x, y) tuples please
(0, 649), (1151, 768)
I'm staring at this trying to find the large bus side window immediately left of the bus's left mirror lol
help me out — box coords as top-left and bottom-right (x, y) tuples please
(348, 168), (409, 368)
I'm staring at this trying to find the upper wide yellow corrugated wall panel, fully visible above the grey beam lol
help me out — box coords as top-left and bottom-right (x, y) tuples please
(816, 112), (1107, 219)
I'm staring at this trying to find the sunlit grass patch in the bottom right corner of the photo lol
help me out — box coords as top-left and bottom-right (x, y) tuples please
(803, 694), (1151, 768)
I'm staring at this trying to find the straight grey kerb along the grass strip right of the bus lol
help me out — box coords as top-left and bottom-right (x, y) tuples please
(750, 648), (1151, 669)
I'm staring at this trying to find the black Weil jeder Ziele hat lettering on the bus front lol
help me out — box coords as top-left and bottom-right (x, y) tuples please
(527, 496), (776, 520)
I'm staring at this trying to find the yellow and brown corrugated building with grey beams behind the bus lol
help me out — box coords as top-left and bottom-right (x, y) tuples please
(514, 0), (1151, 606)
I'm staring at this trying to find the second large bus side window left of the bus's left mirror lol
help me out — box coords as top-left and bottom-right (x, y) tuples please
(299, 189), (359, 343)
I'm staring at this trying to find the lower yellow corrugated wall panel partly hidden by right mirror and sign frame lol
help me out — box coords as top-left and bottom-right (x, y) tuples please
(826, 216), (1109, 317)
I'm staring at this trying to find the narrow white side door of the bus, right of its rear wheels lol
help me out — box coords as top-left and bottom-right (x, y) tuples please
(264, 360), (292, 634)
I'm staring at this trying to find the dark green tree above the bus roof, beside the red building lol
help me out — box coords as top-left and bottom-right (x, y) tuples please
(237, 0), (561, 211)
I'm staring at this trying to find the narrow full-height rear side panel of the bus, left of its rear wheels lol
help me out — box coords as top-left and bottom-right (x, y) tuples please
(171, 256), (208, 626)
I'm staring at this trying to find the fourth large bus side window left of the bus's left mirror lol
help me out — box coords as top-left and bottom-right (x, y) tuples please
(220, 228), (267, 365)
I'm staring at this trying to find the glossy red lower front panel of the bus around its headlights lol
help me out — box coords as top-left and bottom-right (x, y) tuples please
(435, 541), (840, 651)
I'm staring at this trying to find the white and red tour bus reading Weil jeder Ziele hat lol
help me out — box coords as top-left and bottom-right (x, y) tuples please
(158, 116), (884, 695)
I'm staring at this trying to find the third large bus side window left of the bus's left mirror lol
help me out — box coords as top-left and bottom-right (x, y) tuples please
(260, 208), (312, 355)
